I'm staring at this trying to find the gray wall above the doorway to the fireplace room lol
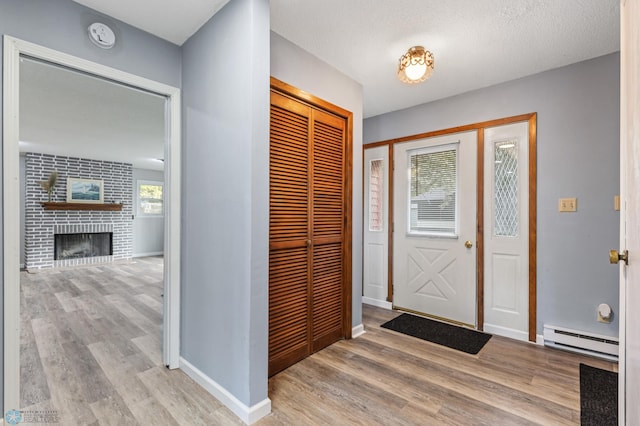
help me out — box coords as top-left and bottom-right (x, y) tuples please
(0, 0), (181, 412)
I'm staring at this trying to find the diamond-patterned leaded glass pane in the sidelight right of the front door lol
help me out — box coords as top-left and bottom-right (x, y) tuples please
(493, 139), (520, 237)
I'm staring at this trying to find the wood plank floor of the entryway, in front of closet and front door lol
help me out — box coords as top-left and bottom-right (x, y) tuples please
(259, 305), (617, 426)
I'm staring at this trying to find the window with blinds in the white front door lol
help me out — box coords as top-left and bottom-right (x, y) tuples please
(408, 144), (458, 236)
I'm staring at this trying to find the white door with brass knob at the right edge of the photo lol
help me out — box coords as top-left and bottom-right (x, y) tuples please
(618, 1), (640, 425)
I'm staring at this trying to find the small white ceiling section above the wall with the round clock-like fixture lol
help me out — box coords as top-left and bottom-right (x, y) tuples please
(73, 0), (229, 46)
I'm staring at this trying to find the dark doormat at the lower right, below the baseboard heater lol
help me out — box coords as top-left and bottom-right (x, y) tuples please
(580, 364), (618, 426)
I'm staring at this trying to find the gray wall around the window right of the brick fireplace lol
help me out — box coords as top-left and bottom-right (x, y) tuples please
(133, 169), (164, 257)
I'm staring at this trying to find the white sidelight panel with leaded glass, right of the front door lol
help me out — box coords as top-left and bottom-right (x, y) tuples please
(483, 121), (529, 341)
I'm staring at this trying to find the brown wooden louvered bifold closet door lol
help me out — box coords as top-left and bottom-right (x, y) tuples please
(269, 91), (346, 375)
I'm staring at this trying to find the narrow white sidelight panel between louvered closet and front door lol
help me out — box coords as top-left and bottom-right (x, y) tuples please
(362, 145), (391, 307)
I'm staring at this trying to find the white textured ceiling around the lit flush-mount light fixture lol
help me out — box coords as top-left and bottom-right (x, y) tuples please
(271, 0), (620, 117)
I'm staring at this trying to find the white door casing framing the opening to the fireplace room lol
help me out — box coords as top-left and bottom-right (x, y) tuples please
(3, 36), (180, 410)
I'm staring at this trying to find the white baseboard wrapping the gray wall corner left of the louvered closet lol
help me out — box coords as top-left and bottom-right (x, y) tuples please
(180, 357), (271, 425)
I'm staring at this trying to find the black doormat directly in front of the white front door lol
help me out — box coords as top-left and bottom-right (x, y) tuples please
(381, 314), (491, 355)
